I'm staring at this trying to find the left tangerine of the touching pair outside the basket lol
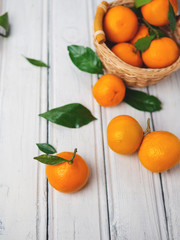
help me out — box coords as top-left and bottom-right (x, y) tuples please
(107, 115), (143, 154)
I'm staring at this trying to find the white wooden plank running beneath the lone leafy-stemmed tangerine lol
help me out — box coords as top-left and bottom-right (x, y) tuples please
(49, 0), (109, 240)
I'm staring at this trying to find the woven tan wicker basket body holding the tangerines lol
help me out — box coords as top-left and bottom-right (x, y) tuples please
(94, 0), (180, 87)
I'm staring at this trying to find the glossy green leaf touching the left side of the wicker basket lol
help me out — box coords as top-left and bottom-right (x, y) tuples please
(68, 45), (103, 74)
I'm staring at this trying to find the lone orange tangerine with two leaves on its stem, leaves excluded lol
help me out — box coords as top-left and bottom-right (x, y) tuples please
(46, 152), (89, 193)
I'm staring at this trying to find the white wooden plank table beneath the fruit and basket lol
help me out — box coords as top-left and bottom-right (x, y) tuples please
(0, 0), (180, 240)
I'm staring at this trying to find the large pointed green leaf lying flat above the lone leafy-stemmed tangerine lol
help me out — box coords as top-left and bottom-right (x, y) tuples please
(39, 103), (96, 128)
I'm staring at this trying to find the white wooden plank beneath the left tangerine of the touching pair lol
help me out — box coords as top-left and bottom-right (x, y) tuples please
(95, 0), (167, 240)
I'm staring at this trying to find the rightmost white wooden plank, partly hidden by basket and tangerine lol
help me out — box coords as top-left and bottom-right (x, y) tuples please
(150, 71), (180, 240)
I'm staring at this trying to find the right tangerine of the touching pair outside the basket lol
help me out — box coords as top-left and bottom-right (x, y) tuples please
(138, 131), (180, 172)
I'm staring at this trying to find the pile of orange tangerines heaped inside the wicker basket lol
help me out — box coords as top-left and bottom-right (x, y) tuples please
(103, 0), (179, 68)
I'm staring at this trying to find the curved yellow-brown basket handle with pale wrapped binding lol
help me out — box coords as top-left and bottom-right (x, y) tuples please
(94, 1), (109, 44)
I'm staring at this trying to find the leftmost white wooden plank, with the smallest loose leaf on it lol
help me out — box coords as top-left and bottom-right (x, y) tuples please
(0, 0), (47, 240)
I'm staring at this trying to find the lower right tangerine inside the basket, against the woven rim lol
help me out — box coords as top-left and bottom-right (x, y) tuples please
(142, 37), (179, 68)
